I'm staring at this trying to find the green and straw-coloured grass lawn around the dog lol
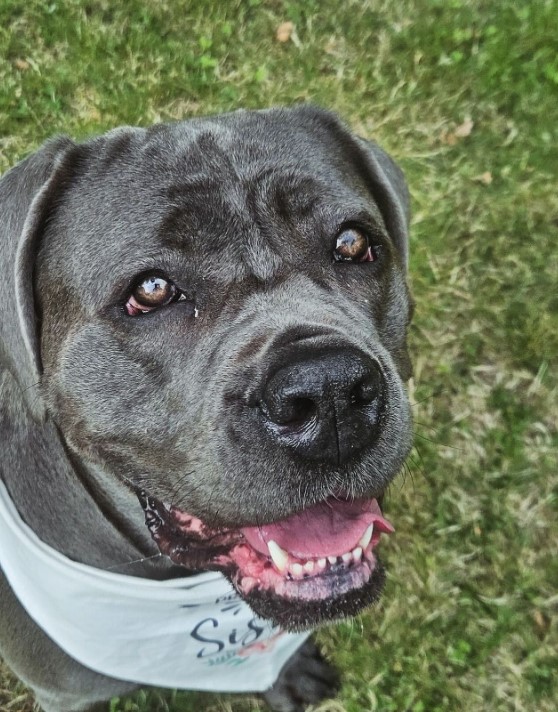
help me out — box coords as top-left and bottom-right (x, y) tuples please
(0, 0), (558, 712)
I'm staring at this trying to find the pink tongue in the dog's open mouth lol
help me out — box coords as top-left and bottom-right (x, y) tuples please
(241, 499), (394, 559)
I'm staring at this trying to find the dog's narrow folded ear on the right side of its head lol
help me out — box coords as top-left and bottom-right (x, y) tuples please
(356, 136), (411, 269)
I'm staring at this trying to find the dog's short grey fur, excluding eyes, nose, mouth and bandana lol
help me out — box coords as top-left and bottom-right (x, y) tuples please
(0, 107), (411, 712)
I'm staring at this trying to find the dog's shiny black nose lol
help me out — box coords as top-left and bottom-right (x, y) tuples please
(260, 349), (383, 463)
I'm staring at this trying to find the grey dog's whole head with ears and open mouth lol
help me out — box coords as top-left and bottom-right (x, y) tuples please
(0, 107), (411, 627)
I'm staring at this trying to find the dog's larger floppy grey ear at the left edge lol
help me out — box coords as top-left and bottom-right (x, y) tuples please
(0, 137), (75, 419)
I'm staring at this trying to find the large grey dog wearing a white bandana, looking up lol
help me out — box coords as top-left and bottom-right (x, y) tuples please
(0, 105), (412, 712)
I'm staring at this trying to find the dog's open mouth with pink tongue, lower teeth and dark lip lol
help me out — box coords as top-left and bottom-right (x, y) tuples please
(138, 491), (394, 630)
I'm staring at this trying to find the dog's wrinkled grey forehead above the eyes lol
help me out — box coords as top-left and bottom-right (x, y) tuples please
(38, 114), (381, 300)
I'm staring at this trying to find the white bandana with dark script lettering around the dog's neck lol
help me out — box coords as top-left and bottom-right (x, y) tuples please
(0, 482), (309, 692)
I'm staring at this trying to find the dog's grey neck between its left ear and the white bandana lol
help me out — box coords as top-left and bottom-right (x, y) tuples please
(0, 371), (171, 578)
